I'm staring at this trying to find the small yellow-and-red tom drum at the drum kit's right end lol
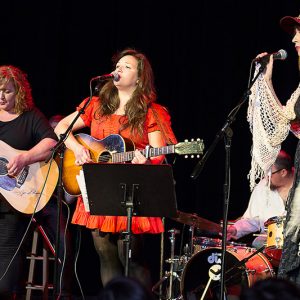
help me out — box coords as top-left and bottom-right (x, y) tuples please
(265, 217), (285, 265)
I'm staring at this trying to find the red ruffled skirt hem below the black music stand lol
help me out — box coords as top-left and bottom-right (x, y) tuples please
(72, 197), (164, 234)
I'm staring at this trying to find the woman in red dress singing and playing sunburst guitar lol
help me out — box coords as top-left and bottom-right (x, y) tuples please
(55, 49), (176, 286)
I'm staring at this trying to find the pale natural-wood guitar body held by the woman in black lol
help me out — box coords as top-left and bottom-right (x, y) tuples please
(0, 141), (58, 214)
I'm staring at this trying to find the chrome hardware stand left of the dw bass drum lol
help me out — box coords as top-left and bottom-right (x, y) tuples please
(152, 229), (186, 300)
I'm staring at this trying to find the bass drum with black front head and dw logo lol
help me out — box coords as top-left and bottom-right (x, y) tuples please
(180, 247), (274, 300)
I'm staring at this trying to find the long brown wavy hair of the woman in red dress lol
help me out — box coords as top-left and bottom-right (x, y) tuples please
(95, 49), (156, 135)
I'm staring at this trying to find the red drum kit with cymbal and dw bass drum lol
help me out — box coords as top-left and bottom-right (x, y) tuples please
(152, 212), (284, 300)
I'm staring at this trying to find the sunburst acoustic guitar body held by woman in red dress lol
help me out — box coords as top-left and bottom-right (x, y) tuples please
(62, 133), (134, 196)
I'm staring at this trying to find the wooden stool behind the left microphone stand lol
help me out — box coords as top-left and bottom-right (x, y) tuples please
(26, 219), (55, 300)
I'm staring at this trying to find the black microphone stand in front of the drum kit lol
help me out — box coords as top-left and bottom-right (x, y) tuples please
(191, 61), (268, 300)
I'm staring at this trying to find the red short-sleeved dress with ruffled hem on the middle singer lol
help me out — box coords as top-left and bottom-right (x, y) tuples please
(72, 97), (176, 234)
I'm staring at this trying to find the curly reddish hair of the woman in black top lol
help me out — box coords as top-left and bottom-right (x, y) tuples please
(0, 65), (34, 114)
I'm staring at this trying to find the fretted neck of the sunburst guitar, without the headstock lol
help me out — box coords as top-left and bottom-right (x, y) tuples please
(112, 145), (175, 163)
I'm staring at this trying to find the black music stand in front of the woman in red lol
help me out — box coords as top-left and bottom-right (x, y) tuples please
(82, 163), (177, 276)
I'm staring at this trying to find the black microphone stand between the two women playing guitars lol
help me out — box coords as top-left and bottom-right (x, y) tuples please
(45, 79), (98, 299)
